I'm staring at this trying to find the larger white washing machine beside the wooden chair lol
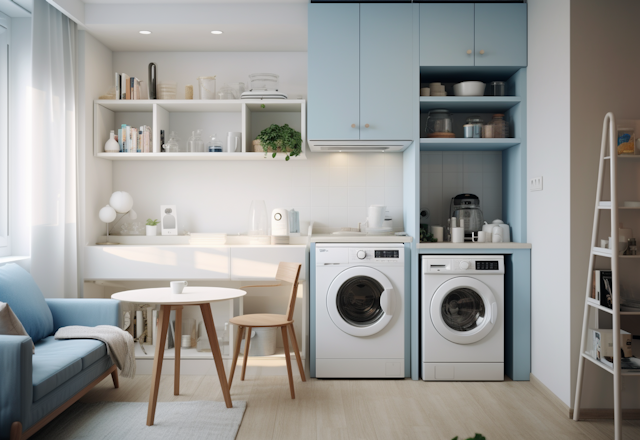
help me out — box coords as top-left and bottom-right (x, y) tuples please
(315, 243), (405, 378)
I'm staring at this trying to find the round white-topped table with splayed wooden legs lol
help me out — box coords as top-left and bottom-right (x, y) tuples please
(111, 287), (247, 426)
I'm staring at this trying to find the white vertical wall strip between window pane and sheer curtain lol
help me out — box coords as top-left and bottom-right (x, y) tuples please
(9, 18), (31, 269)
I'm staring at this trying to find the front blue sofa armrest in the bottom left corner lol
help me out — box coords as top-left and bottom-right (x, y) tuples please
(0, 335), (33, 439)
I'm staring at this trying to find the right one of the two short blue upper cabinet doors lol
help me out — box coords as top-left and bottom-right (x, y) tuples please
(475, 3), (527, 67)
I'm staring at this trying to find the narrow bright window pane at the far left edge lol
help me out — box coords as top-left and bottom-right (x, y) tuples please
(0, 14), (11, 256)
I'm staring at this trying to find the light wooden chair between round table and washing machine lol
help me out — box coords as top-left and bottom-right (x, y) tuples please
(229, 263), (307, 399)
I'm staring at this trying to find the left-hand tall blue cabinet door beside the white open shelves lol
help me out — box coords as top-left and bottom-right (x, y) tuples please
(307, 3), (360, 140)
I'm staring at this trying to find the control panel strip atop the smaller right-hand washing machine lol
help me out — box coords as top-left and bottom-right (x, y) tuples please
(422, 255), (504, 274)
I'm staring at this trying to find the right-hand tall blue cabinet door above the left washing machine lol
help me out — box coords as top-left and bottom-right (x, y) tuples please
(360, 3), (418, 140)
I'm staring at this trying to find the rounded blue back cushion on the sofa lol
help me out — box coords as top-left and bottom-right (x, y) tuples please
(0, 264), (53, 342)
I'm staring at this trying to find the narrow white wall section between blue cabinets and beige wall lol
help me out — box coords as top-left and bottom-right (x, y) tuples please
(527, 0), (573, 405)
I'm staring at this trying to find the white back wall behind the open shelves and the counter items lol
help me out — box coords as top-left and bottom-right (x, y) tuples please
(105, 52), (403, 240)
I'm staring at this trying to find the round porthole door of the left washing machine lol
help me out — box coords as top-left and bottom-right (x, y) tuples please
(327, 267), (398, 336)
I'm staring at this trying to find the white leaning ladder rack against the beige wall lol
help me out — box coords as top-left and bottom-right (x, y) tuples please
(573, 112), (640, 440)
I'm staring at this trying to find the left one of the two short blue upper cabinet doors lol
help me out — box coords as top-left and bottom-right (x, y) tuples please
(420, 3), (474, 66)
